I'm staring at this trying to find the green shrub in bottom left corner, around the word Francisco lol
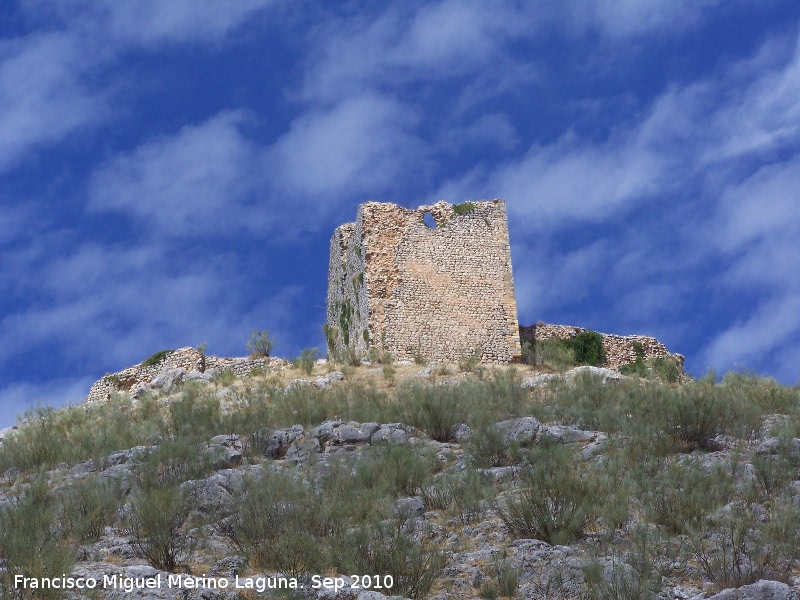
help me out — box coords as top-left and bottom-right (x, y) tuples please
(0, 477), (77, 600)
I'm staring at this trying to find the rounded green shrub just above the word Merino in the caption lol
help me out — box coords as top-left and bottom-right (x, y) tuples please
(125, 484), (192, 571)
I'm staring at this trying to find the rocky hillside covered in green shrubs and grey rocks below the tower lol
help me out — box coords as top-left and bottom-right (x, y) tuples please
(0, 357), (800, 600)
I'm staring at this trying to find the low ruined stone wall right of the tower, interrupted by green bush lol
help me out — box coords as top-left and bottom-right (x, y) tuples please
(519, 323), (684, 369)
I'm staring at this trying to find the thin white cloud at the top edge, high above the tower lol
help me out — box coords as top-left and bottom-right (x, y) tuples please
(304, 0), (536, 99)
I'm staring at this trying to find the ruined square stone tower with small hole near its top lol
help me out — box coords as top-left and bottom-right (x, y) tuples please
(326, 200), (521, 362)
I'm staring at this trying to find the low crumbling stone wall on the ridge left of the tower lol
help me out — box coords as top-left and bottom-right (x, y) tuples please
(86, 347), (286, 402)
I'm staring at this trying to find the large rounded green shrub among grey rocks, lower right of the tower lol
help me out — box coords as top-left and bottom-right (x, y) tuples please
(496, 445), (595, 545)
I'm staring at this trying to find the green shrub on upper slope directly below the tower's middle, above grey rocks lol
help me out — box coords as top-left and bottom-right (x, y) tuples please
(397, 383), (471, 442)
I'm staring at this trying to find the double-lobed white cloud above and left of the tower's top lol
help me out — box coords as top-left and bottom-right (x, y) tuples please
(88, 95), (424, 236)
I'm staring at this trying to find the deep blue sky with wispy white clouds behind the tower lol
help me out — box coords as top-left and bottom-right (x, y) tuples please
(0, 0), (800, 427)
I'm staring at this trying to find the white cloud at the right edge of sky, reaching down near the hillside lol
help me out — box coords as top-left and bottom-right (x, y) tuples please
(704, 156), (800, 381)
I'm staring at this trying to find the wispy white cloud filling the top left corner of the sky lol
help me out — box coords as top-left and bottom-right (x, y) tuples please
(0, 0), (270, 172)
